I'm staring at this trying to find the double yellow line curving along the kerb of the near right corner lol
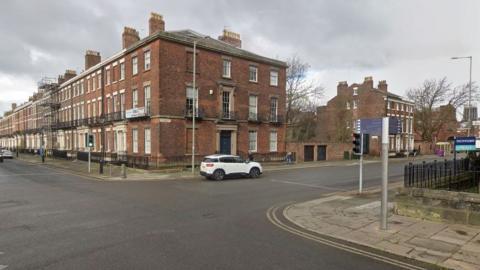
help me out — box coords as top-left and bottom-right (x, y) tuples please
(267, 205), (427, 270)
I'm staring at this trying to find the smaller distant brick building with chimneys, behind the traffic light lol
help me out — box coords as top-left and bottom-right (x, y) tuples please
(317, 77), (414, 154)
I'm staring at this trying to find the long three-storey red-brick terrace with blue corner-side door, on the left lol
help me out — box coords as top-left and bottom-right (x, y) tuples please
(0, 13), (286, 165)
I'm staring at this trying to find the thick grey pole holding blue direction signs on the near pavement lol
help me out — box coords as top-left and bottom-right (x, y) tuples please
(380, 117), (389, 230)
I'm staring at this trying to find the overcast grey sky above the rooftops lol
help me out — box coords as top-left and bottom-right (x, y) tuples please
(0, 0), (480, 113)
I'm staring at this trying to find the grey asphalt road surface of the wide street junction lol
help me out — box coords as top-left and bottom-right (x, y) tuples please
(0, 157), (436, 270)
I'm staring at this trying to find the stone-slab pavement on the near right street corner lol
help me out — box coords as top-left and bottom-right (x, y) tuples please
(283, 188), (480, 270)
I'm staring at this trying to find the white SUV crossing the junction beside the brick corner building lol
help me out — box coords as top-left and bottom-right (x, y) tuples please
(200, 155), (263, 180)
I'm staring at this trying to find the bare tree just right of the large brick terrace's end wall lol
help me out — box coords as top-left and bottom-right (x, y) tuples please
(286, 56), (324, 141)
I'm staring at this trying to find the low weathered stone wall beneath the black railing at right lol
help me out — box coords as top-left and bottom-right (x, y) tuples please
(394, 188), (480, 226)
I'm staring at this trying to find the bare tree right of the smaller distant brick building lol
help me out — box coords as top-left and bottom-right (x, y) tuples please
(407, 77), (478, 142)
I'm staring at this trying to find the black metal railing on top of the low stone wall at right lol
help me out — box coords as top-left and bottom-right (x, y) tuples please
(404, 159), (480, 191)
